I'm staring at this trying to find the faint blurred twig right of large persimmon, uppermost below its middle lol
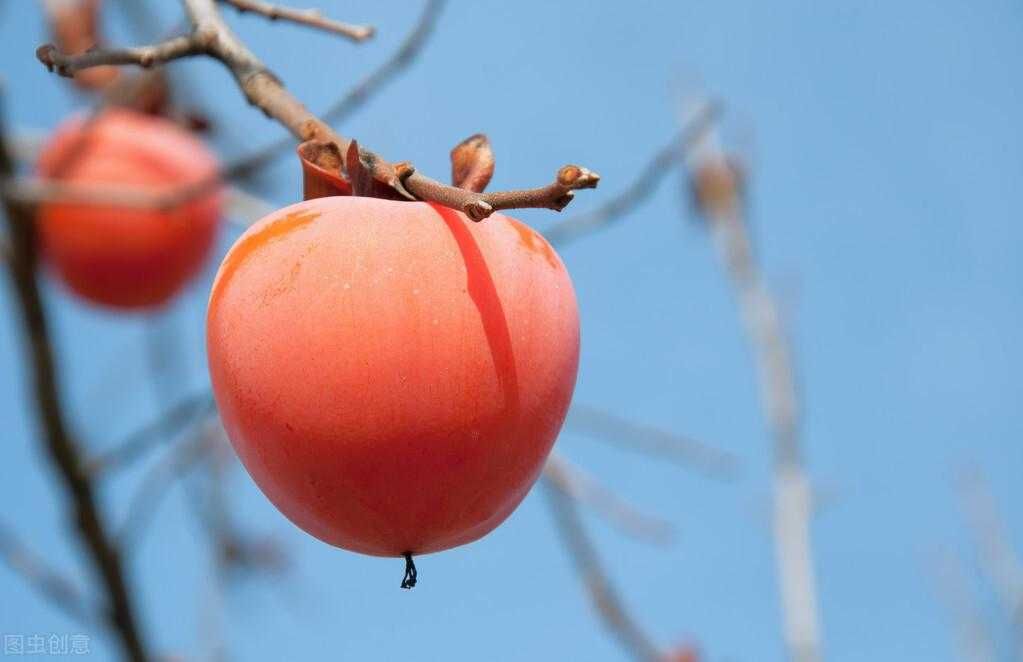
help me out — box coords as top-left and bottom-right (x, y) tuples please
(565, 403), (740, 479)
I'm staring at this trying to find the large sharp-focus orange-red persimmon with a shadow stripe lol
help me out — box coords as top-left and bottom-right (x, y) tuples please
(207, 196), (579, 557)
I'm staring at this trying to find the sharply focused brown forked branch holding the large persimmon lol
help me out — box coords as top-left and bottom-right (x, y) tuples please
(37, 0), (599, 221)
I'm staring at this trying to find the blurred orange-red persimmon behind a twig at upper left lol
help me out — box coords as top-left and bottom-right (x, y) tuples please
(37, 109), (222, 309)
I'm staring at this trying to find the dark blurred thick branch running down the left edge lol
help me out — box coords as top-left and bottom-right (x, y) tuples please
(0, 104), (149, 661)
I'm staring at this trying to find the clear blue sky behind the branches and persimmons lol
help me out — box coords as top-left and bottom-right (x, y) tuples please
(0, 0), (1023, 662)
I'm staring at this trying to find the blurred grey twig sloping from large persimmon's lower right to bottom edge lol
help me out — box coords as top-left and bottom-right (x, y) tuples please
(541, 479), (662, 662)
